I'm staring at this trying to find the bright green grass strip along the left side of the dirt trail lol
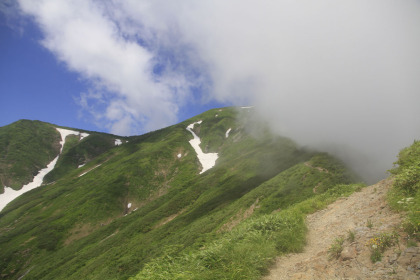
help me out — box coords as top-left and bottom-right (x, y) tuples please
(131, 184), (363, 280)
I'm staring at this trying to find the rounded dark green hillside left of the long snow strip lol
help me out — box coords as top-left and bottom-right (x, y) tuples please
(0, 120), (61, 193)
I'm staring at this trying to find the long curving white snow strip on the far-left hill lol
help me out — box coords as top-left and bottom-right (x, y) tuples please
(0, 128), (79, 211)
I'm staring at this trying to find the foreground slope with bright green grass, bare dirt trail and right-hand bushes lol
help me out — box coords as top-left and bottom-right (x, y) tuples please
(131, 141), (420, 280)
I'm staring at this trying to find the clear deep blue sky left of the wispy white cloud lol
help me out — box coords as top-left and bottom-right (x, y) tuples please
(0, 15), (96, 129)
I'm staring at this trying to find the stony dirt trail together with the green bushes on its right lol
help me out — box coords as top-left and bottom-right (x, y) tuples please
(265, 141), (420, 279)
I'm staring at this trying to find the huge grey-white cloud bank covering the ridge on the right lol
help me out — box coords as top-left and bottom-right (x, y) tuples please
(161, 0), (420, 178)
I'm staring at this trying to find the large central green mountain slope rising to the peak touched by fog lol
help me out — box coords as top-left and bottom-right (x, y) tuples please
(0, 108), (356, 279)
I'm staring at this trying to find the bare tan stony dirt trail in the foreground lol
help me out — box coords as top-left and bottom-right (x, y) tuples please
(264, 179), (420, 280)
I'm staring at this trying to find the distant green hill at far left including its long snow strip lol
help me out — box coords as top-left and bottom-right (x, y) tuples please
(0, 120), (121, 211)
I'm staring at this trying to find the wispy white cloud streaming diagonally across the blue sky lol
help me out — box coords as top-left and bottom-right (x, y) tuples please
(20, 0), (188, 135)
